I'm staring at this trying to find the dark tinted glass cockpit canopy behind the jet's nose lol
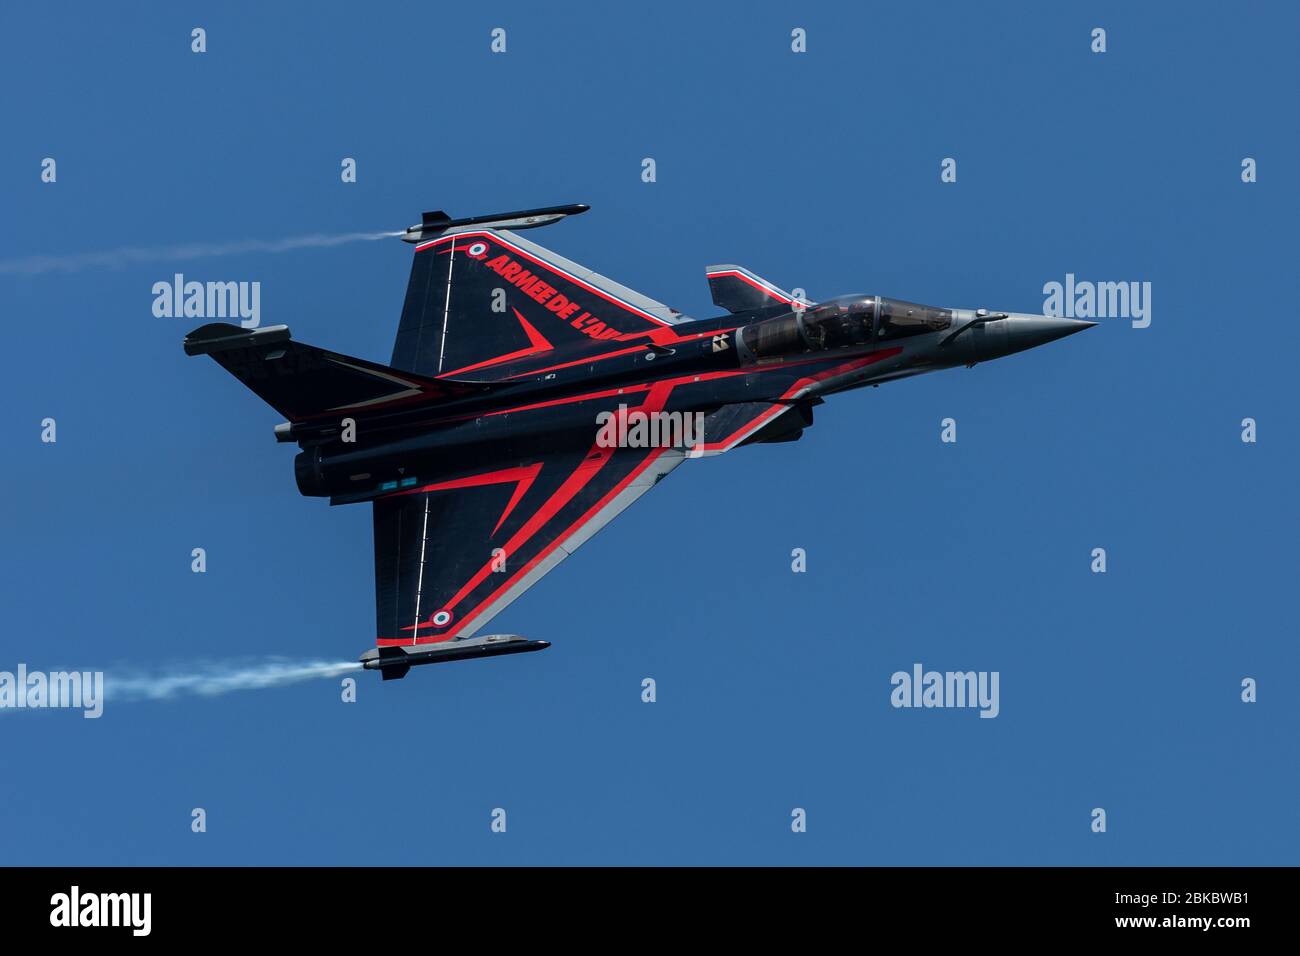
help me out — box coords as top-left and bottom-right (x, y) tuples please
(741, 295), (953, 359)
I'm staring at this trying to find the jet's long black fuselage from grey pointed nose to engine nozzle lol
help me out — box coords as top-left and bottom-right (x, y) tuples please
(295, 295), (1093, 503)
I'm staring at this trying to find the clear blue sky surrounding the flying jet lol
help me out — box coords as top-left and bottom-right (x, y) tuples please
(0, 3), (1300, 864)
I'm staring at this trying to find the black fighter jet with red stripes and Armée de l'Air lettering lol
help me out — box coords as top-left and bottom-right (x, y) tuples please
(185, 206), (1095, 680)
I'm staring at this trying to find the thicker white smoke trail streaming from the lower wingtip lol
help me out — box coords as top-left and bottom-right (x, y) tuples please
(104, 659), (361, 704)
